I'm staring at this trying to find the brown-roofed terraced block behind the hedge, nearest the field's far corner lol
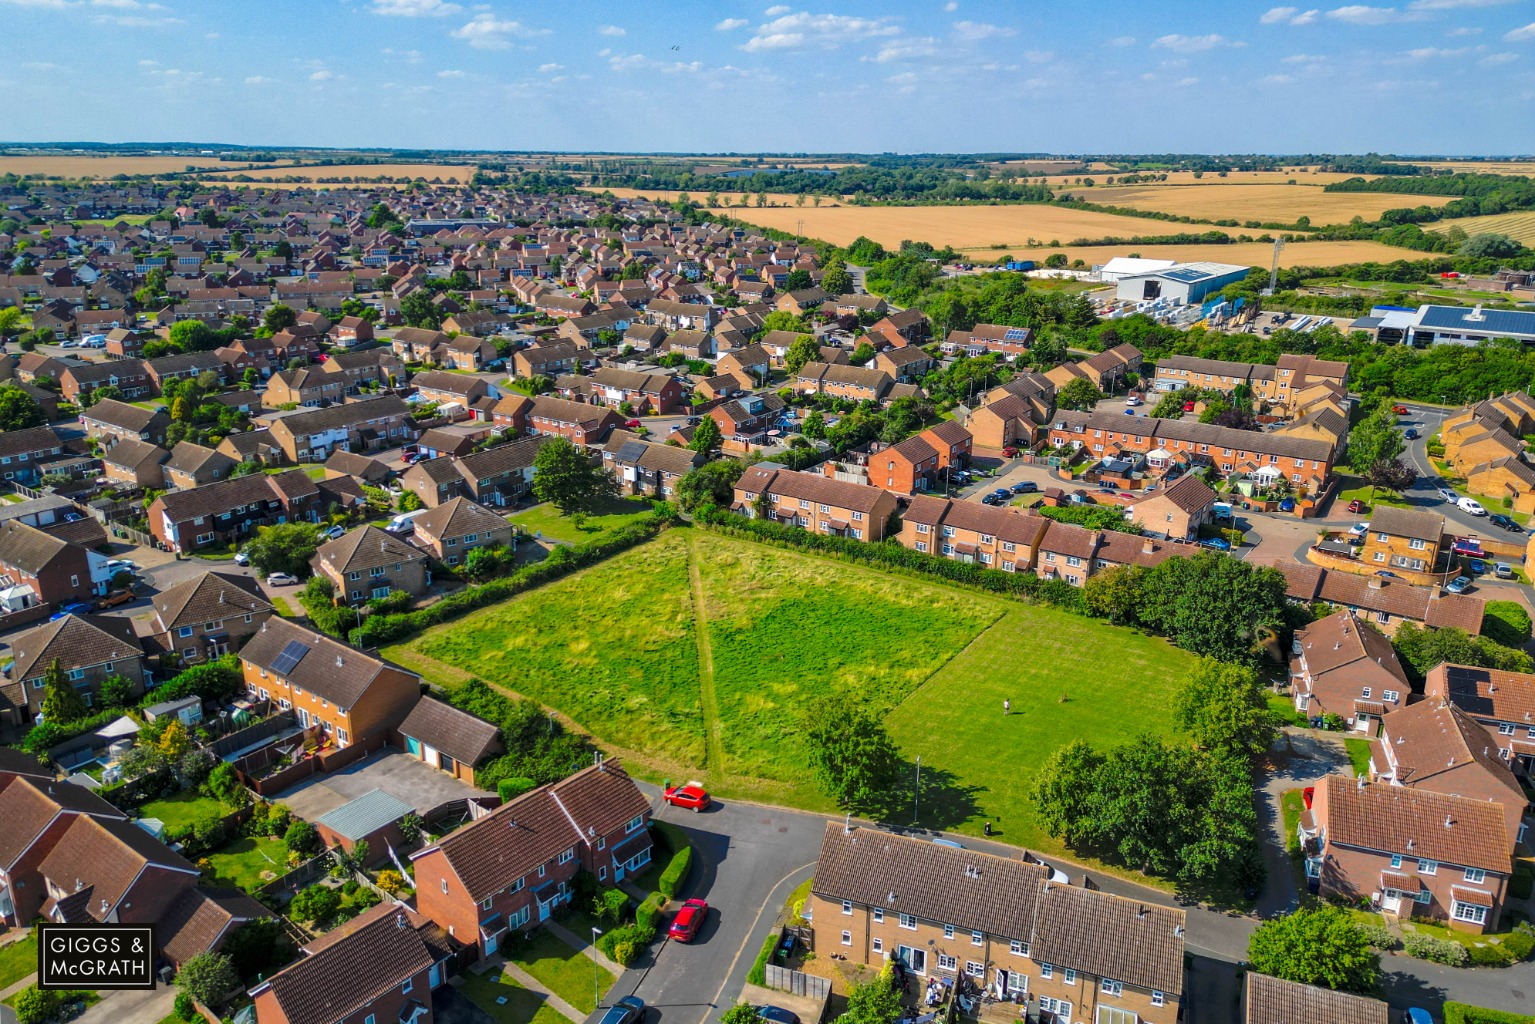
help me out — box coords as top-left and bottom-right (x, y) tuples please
(731, 462), (896, 540)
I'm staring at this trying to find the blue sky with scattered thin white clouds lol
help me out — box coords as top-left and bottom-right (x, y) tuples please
(0, 0), (1535, 155)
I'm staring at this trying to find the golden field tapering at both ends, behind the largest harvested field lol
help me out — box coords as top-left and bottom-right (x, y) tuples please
(1084, 184), (1454, 227)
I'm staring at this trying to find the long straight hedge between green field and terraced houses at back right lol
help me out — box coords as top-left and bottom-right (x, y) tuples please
(694, 507), (1087, 614)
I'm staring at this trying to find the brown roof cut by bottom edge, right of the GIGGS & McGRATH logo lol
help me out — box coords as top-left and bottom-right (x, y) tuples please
(253, 903), (433, 1024)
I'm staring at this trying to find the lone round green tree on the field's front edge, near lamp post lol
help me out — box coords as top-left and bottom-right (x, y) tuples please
(804, 694), (901, 809)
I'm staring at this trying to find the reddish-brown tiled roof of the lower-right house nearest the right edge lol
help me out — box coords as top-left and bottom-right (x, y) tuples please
(1312, 776), (1510, 875)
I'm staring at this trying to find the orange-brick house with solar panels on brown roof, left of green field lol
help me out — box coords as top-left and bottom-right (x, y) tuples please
(239, 619), (421, 748)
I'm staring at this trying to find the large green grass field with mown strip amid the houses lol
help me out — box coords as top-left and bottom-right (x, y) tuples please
(385, 528), (1193, 851)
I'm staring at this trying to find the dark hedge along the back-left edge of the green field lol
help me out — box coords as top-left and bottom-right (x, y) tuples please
(347, 514), (672, 648)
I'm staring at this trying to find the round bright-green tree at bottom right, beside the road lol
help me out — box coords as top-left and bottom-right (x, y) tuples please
(1248, 907), (1380, 995)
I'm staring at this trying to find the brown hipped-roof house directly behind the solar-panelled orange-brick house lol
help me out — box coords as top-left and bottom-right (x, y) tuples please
(149, 573), (275, 665)
